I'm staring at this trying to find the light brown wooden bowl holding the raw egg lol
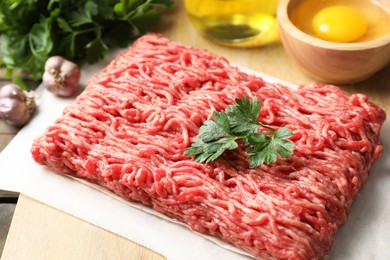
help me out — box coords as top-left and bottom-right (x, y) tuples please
(277, 0), (390, 84)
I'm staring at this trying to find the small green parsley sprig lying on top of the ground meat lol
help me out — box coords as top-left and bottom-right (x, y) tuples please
(185, 97), (294, 168)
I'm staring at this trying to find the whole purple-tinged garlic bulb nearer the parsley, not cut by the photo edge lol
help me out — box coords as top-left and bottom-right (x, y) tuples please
(42, 56), (81, 97)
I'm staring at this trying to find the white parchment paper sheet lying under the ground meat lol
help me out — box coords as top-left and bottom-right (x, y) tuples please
(0, 60), (390, 260)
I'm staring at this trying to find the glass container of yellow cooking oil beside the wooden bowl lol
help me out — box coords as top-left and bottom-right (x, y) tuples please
(185, 0), (279, 47)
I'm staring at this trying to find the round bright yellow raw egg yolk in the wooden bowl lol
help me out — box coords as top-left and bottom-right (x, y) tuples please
(312, 5), (367, 42)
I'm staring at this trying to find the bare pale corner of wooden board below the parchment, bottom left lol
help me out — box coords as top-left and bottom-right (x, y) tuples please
(2, 195), (165, 260)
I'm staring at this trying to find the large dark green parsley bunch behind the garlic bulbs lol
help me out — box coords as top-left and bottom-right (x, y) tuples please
(0, 0), (173, 80)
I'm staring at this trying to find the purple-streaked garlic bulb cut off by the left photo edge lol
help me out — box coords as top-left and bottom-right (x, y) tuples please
(0, 84), (36, 127)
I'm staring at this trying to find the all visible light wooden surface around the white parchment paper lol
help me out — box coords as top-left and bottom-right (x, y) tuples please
(0, 1), (390, 260)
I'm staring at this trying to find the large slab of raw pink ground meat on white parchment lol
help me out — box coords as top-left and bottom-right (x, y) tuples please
(31, 34), (386, 259)
